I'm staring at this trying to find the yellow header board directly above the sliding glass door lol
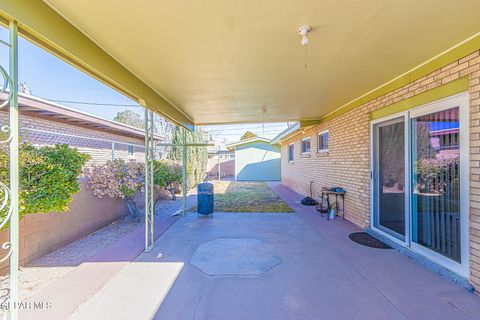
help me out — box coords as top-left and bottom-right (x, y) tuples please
(370, 77), (470, 120)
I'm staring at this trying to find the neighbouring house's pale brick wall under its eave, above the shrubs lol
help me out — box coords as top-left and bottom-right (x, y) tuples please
(0, 112), (145, 164)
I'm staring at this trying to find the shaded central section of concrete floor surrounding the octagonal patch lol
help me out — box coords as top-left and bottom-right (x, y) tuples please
(148, 213), (406, 319)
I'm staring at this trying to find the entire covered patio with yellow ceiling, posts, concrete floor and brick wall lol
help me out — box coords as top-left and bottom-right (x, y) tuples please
(0, 0), (480, 320)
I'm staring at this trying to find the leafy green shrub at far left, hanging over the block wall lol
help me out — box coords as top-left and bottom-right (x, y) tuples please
(0, 143), (90, 220)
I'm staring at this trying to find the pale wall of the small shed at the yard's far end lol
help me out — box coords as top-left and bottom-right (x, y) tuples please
(235, 141), (281, 181)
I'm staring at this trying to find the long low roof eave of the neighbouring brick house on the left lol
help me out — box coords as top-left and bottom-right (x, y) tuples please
(0, 93), (166, 140)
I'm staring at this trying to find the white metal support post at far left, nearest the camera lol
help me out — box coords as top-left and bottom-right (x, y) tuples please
(9, 21), (20, 320)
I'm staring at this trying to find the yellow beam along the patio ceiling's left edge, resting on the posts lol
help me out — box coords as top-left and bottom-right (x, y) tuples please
(0, 0), (193, 129)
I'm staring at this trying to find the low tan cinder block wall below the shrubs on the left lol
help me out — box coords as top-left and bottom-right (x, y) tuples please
(0, 182), (127, 275)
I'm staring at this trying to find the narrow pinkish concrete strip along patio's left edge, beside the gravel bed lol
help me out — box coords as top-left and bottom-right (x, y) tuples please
(20, 196), (195, 320)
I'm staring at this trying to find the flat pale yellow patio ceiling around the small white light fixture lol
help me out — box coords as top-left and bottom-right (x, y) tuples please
(17, 0), (480, 124)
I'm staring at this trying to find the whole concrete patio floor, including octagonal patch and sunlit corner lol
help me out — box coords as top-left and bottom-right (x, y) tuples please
(22, 183), (480, 320)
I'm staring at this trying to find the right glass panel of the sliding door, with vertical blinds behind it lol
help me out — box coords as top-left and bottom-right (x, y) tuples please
(411, 107), (461, 262)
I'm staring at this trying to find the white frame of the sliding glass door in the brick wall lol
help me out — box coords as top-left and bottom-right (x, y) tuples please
(370, 92), (470, 279)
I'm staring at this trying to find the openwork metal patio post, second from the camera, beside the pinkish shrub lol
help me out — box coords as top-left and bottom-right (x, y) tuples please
(145, 108), (155, 252)
